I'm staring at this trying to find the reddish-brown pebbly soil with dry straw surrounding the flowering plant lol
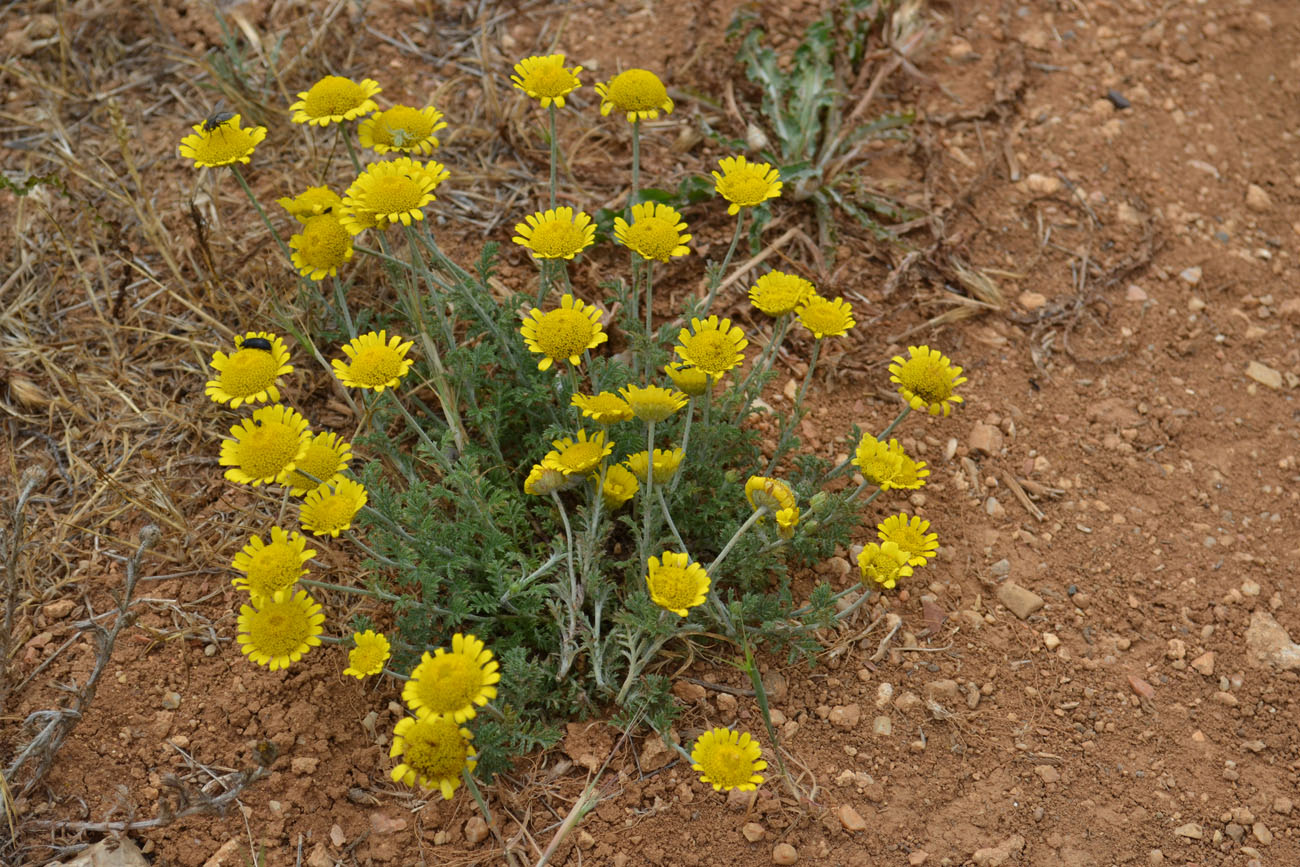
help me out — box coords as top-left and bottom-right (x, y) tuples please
(0, 0), (1300, 867)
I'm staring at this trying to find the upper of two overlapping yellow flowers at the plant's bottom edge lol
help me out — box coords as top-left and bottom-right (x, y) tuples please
(402, 632), (501, 723)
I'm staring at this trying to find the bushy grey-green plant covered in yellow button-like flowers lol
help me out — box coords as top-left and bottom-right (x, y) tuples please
(189, 55), (965, 810)
